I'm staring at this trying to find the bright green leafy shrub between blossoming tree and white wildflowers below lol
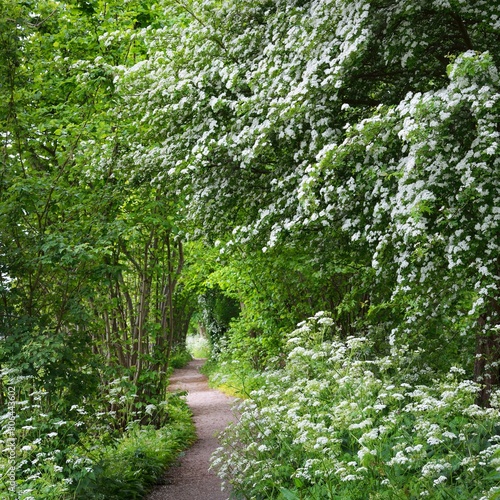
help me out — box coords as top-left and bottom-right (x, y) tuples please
(203, 242), (372, 369)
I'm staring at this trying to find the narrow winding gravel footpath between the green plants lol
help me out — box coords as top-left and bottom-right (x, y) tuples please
(147, 359), (234, 500)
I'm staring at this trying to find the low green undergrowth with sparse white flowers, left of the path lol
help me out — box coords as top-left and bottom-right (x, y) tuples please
(0, 372), (195, 500)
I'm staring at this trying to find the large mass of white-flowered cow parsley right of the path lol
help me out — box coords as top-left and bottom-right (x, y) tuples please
(212, 313), (500, 500)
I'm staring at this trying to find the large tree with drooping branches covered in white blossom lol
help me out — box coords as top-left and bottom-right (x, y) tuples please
(118, 0), (500, 404)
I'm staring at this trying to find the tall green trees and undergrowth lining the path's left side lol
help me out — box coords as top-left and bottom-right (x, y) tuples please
(0, 0), (196, 499)
